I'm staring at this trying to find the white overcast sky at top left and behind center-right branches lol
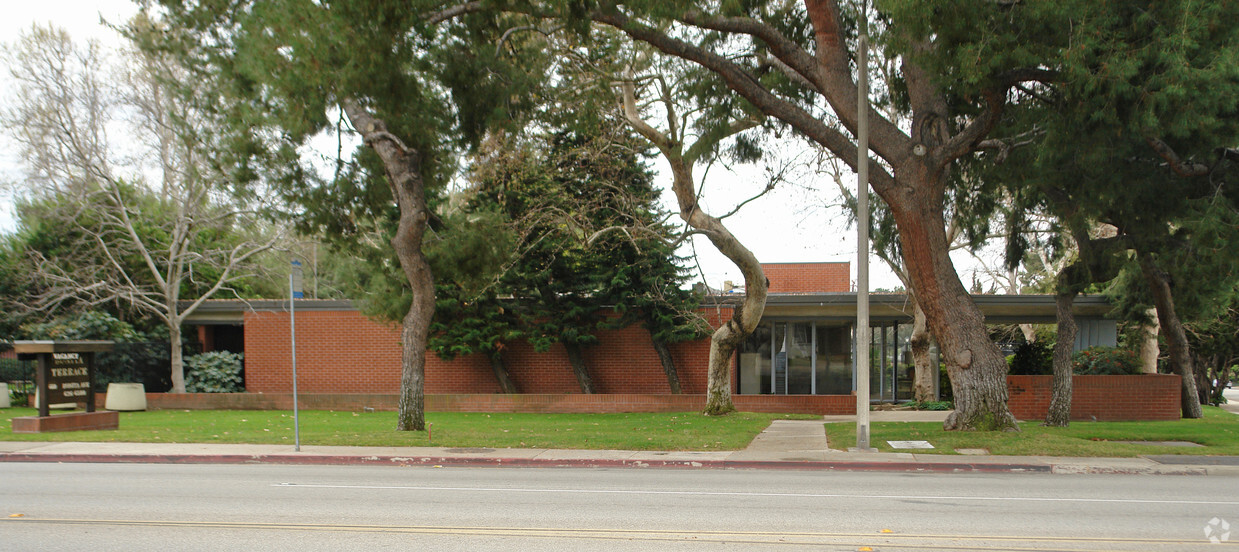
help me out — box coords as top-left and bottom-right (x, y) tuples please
(0, 0), (921, 288)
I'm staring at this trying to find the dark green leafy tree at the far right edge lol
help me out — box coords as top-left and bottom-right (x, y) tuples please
(976, 0), (1239, 423)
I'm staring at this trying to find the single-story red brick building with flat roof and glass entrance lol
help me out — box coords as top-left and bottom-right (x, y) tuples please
(187, 262), (1114, 413)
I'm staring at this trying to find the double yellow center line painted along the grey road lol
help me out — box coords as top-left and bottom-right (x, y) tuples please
(0, 516), (1239, 552)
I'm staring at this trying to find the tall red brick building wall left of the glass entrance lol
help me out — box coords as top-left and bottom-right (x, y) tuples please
(245, 307), (731, 395)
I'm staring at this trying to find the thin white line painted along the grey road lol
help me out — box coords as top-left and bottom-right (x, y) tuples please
(271, 483), (1239, 506)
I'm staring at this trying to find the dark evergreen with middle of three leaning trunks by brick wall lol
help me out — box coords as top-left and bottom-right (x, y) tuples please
(478, 115), (691, 392)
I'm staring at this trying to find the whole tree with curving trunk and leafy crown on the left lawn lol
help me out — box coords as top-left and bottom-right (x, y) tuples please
(147, 0), (540, 431)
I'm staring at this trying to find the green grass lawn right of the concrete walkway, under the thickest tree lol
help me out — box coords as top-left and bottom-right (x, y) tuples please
(826, 406), (1239, 457)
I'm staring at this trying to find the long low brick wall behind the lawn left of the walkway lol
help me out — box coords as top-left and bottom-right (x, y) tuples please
(120, 392), (856, 415)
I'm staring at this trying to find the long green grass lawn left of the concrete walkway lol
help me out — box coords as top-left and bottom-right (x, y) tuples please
(0, 408), (819, 451)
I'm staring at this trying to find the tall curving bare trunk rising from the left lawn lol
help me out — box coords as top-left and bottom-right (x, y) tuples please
(343, 99), (435, 431)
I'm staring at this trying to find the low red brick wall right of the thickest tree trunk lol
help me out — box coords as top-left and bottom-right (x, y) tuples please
(1007, 374), (1181, 422)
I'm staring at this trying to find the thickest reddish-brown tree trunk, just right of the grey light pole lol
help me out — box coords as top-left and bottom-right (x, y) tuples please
(883, 172), (1018, 431)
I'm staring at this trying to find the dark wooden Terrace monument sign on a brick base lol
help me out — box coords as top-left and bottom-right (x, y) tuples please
(12, 342), (120, 433)
